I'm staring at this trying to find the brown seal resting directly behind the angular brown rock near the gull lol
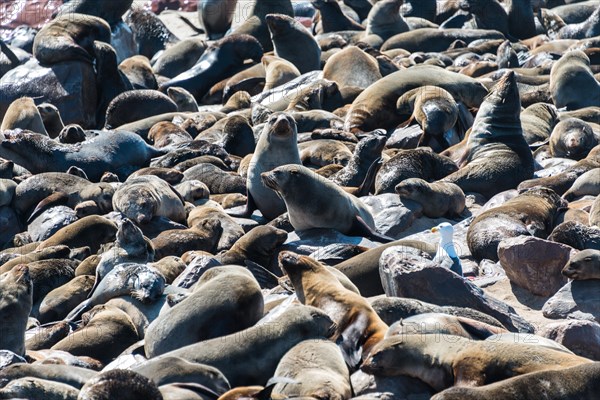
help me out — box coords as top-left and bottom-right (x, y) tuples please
(467, 187), (567, 261)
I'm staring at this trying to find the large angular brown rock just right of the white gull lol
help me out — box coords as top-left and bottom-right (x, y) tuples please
(498, 236), (575, 296)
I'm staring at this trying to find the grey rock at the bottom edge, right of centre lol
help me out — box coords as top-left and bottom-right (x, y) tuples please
(350, 370), (435, 400)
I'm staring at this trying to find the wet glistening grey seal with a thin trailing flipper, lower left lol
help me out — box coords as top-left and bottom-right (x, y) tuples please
(65, 263), (166, 321)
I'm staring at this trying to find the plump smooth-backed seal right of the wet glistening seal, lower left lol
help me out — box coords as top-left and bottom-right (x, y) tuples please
(144, 267), (263, 358)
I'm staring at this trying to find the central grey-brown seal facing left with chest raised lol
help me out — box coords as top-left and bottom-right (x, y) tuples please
(261, 165), (393, 242)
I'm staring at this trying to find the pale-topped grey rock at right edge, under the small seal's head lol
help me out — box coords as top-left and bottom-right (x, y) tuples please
(542, 279), (600, 322)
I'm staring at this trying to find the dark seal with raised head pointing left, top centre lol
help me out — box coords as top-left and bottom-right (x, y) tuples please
(265, 14), (321, 74)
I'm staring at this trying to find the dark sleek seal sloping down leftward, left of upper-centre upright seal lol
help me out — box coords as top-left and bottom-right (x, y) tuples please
(160, 34), (263, 101)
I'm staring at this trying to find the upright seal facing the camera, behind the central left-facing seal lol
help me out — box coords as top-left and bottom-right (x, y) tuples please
(230, 112), (302, 219)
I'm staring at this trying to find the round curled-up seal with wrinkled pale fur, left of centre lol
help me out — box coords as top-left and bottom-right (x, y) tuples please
(113, 175), (185, 225)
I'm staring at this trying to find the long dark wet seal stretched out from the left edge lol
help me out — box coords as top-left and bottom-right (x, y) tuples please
(0, 131), (162, 182)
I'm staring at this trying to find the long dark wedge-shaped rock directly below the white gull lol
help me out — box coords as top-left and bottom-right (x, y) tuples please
(379, 250), (534, 333)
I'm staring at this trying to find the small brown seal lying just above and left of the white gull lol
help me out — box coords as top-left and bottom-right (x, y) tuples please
(396, 178), (465, 218)
